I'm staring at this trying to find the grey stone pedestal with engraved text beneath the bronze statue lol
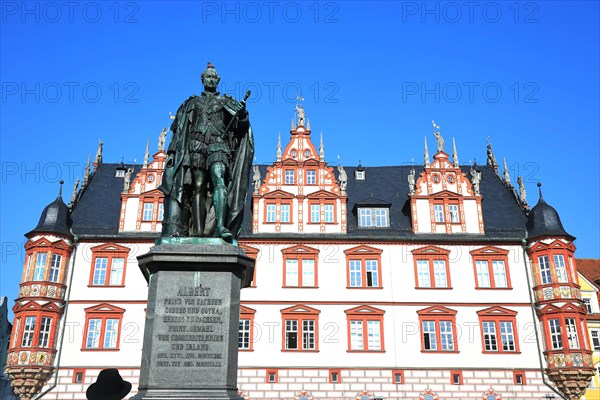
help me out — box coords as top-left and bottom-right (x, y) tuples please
(131, 238), (254, 400)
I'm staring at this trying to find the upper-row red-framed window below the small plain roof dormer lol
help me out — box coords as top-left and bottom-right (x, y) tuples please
(344, 246), (383, 288)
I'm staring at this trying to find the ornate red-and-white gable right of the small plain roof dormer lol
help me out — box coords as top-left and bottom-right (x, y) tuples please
(409, 126), (484, 234)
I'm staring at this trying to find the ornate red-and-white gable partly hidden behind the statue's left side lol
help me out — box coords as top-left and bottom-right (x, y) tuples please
(119, 140), (167, 232)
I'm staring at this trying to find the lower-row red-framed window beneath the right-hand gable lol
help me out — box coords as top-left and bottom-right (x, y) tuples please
(417, 306), (458, 353)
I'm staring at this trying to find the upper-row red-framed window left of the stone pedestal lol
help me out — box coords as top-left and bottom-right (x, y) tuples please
(89, 243), (129, 286)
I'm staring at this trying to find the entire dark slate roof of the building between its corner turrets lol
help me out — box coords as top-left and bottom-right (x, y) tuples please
(72, 164), (527, 241)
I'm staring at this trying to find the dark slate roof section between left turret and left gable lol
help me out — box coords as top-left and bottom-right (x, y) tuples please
(71, 163), (142, 236)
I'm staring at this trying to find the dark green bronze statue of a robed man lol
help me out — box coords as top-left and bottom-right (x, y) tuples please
(159, 62), (254, 243)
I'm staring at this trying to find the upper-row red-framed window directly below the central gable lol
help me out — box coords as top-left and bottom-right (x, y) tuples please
(281, 245), (319, 287)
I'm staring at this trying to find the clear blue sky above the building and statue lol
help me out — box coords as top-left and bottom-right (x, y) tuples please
(0, 1), (600, 318)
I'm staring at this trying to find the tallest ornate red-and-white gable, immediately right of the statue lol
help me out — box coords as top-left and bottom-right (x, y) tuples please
(252, 104), (347, 234)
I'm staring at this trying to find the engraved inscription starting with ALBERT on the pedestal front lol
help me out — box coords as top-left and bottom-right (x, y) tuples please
(154, 286), (225, 368)
